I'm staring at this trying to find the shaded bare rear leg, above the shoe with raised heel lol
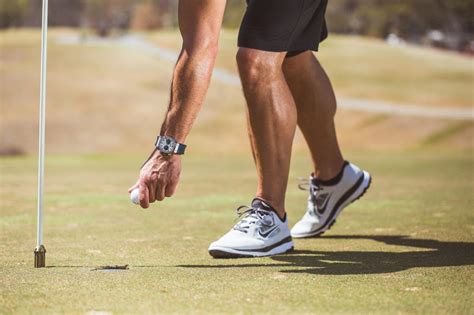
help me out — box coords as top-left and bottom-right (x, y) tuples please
(283, 51), (344, 180)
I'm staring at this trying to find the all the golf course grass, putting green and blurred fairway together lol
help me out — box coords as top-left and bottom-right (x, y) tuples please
(0, 28), (474, 314)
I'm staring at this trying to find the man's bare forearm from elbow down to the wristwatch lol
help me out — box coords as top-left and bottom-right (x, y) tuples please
(161, 46), (217, 142)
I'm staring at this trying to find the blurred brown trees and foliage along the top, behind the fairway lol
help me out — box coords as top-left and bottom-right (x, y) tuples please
(0, 0), (474, 51)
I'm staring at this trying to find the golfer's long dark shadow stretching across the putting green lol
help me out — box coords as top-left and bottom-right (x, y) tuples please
(178, 235), (474, 275)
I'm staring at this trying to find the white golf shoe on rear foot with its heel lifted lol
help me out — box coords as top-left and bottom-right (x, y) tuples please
(291, 162), (371, 238)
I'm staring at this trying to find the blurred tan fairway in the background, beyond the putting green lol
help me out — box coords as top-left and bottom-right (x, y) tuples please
(0, 28), (474, 155)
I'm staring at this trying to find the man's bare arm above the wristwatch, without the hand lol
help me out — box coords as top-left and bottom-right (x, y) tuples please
(161, 0), (226, 142)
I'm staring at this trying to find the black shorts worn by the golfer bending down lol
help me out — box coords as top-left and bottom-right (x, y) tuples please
(238, 0), (328, 53)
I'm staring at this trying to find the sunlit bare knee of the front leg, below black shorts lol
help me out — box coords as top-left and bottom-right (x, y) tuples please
(236, 48), (281, 83)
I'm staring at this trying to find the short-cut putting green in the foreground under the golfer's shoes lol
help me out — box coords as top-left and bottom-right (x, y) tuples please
(0, 151), (474, 314)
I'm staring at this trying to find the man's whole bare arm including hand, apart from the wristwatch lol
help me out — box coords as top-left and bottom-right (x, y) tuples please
(129, 0), (226, 208)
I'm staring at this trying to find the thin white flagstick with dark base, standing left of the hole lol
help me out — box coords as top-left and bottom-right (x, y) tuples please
(35, 0), (48, 268)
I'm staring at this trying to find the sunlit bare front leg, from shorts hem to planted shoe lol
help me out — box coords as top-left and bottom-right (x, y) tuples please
(237, 48), (296, 217)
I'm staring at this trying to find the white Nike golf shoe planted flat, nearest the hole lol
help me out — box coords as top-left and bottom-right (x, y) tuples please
(209, 199), (293, 258)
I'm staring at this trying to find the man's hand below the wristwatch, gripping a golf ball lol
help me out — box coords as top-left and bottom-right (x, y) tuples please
(128, 151), (181, 209)
